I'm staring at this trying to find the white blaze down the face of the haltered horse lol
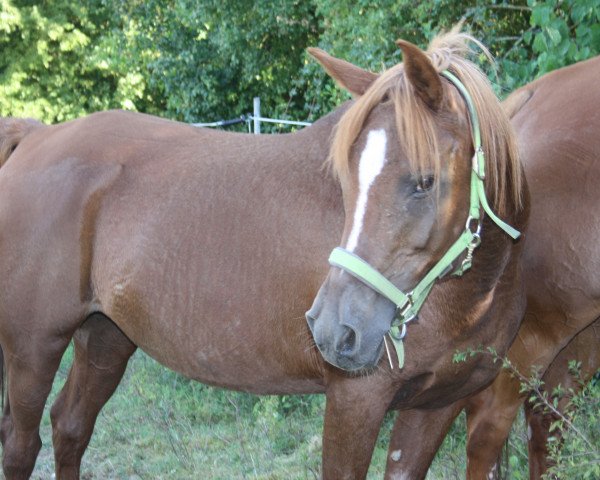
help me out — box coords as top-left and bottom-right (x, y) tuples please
(346, 130), (387, 252)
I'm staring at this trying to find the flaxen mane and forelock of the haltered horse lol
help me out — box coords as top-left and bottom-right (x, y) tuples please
(328, 25), (523, 215)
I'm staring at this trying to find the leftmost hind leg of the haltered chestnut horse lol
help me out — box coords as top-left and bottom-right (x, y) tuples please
(0, 331), (71, 480)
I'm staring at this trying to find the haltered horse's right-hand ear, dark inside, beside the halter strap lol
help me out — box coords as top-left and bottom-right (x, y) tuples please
(396, 40), (444, 111)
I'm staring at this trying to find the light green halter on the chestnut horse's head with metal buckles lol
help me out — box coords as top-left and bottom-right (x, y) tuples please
(329, 70), (521, 368)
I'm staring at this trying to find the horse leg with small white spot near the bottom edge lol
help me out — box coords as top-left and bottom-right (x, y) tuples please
(385, 401), (464, 480)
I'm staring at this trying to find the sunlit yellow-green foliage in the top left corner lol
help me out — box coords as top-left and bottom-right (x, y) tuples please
(0, 0), (144, 122)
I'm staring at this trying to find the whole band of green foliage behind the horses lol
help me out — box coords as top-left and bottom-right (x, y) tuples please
(0, 0), (600, 122)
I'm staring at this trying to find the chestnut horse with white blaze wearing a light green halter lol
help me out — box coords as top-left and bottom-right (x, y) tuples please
(0, 31), (529, 480)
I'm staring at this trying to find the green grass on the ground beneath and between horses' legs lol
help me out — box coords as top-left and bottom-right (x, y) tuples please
(23, 349), (600, 480)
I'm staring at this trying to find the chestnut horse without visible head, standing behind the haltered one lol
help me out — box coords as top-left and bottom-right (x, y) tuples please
(387, 57), (600, 479)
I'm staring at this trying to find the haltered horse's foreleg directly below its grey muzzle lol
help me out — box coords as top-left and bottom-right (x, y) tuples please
(323, 373), (394, 480)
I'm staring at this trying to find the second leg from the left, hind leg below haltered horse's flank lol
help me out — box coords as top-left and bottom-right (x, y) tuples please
(50, 314), (136, 480)
